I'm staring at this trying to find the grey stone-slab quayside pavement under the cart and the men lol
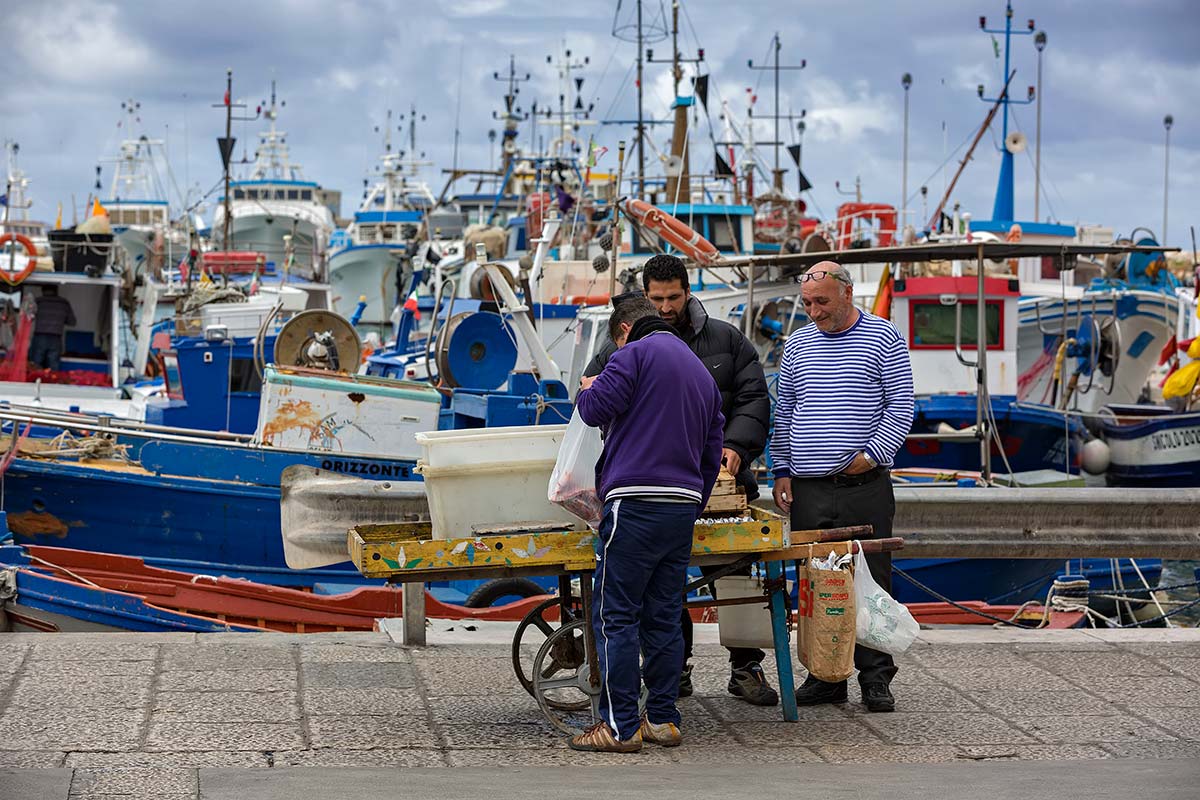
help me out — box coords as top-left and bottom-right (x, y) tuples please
(0, 622), (1200, 800)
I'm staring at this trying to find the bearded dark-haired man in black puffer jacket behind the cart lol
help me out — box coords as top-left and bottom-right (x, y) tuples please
(583, 255), (779, 705)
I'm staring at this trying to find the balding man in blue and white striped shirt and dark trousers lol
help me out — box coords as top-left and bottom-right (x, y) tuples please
(770, 261), (913, 711)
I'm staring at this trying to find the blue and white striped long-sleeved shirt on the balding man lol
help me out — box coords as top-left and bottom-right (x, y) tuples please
(770, 312), (913, 477)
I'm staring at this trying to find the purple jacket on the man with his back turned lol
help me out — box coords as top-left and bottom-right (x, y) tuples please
(575, 331), (725, 509)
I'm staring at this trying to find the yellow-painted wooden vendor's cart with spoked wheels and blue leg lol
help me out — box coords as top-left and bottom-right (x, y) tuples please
(348, 507), (902, 733)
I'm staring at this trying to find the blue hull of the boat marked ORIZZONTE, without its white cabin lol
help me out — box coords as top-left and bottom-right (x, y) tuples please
(5, 440), (415, 587)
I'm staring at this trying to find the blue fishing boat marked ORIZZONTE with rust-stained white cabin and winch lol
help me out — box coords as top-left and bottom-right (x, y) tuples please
(0, 312), (442, 585)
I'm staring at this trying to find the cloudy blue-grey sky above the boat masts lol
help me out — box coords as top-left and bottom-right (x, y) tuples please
(0, 0), (1200, 246)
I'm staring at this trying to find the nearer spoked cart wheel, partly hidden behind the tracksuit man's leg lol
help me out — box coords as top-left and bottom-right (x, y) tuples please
(533, 620), (647, 736)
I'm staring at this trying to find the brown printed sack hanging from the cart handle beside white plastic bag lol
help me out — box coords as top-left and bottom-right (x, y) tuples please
(796, 566), (856, 682)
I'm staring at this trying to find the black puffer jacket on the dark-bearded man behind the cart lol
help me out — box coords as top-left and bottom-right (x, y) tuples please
(583, 296), (770, 499)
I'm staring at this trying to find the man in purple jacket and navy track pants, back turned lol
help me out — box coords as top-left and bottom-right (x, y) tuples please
(569, 296), (725, 753)
